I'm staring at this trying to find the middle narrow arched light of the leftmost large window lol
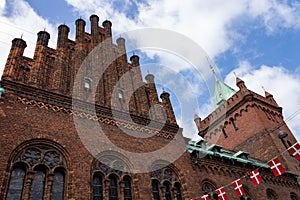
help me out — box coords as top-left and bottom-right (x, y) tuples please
(30, 169), (46, 200)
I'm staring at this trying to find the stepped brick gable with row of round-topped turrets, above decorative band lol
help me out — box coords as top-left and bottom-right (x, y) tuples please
(2, 15), (177, 129)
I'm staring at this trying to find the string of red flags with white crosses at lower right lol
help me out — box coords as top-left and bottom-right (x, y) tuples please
(191, 142), (300, 200)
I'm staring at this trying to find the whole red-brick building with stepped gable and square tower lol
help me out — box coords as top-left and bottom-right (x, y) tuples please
(0, 15), (300, 200)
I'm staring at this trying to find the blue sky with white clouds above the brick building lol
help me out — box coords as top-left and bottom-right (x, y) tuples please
(0, 0), (300, 140)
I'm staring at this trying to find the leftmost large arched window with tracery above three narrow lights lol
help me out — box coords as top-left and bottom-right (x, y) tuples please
(4, 140), (68, 200)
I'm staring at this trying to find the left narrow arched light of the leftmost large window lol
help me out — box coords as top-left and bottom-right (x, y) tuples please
(6, 167), (25, 200)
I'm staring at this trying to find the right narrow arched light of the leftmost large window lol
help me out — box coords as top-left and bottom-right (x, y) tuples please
(51, 171), (65, 200)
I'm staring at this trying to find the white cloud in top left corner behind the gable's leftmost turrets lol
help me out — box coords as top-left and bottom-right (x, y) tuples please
(0, 0), (56, 76)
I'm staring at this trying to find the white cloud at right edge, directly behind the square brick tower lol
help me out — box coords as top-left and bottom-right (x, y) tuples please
(225, 61), (300, 140)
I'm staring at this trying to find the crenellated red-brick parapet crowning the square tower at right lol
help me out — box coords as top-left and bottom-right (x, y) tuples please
(197, 78), (283, 137)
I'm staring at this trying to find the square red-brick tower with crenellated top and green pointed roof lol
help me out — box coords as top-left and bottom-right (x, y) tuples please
(195, 77), (300, 172)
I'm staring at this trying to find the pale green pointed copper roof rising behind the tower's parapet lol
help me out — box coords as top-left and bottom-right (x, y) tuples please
(213, 80), (236, 110)
